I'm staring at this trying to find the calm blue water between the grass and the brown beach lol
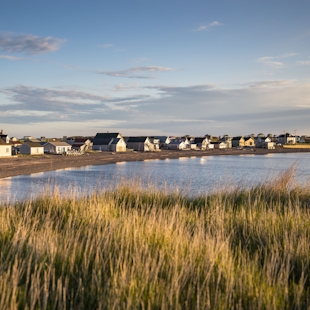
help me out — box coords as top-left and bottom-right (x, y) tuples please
(0, 153), (310, 203)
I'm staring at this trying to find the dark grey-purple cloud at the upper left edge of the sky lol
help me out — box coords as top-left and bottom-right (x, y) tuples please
(0, 33), (66, 55)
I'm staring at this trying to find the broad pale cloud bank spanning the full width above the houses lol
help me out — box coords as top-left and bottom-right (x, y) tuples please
(0, 80), (310, 135)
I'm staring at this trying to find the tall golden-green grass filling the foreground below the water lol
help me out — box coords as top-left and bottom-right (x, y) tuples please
(0, 175), (310, 309)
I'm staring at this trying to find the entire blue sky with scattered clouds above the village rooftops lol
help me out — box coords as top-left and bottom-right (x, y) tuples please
(0, 0), (310, 137)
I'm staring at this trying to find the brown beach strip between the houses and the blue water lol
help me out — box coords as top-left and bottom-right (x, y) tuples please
(0, 148), (310, 179)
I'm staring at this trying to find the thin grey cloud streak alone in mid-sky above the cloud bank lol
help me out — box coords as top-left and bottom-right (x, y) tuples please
(94, 66), (174, 79)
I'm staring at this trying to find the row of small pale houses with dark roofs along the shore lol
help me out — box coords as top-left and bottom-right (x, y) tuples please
(0, 130), (310, 157)
